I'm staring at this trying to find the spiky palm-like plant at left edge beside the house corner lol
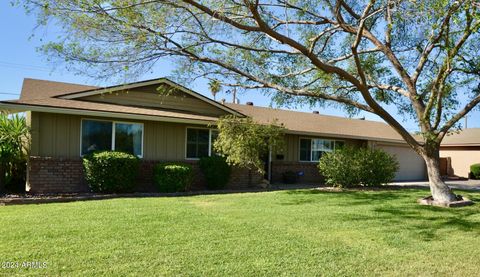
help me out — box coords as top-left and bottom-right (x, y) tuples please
(0, 112), (30, 192)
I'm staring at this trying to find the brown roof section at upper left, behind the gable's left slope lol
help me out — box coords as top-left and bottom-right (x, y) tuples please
(20, 78), (98, 100)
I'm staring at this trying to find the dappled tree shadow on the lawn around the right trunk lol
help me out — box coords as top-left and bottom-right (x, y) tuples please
(281, 189), (480, 241)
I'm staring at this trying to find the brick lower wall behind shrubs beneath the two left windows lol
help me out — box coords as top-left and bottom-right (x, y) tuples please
(27, 157), (263, 194)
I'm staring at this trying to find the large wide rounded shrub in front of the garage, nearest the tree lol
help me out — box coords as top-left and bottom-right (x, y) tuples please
(318, 147), (398, 187)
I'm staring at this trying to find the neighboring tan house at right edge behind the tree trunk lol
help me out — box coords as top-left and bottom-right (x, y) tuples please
(440, 128), (480, 178)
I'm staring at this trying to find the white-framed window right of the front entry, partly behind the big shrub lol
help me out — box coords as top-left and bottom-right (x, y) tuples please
(300, 138), (345, 162)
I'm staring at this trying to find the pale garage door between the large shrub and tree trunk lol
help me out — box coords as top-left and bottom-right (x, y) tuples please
(377, 144), (427, 181)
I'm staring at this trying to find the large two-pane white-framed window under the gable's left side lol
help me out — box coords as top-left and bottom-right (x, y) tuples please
(80, 119), (143, 158)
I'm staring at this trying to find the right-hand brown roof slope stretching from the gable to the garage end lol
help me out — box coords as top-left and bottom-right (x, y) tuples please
(226, 104), (404, 142)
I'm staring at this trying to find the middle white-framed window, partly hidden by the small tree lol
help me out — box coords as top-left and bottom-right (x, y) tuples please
(185, 127), (218, 159)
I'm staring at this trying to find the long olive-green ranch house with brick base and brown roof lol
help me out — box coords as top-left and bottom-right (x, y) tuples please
(0, 78), (426, 193)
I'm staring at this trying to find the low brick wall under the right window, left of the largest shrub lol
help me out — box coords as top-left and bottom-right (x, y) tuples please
(272, 161), (324, 184)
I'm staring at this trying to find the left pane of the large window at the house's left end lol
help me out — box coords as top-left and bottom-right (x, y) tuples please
(82, 120), (112, 155)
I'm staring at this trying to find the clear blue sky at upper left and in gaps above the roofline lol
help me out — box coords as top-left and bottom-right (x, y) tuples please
(0, 1), (480, 131)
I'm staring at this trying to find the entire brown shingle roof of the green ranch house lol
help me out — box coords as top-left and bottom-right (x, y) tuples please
(0, 79), (403, 142)
